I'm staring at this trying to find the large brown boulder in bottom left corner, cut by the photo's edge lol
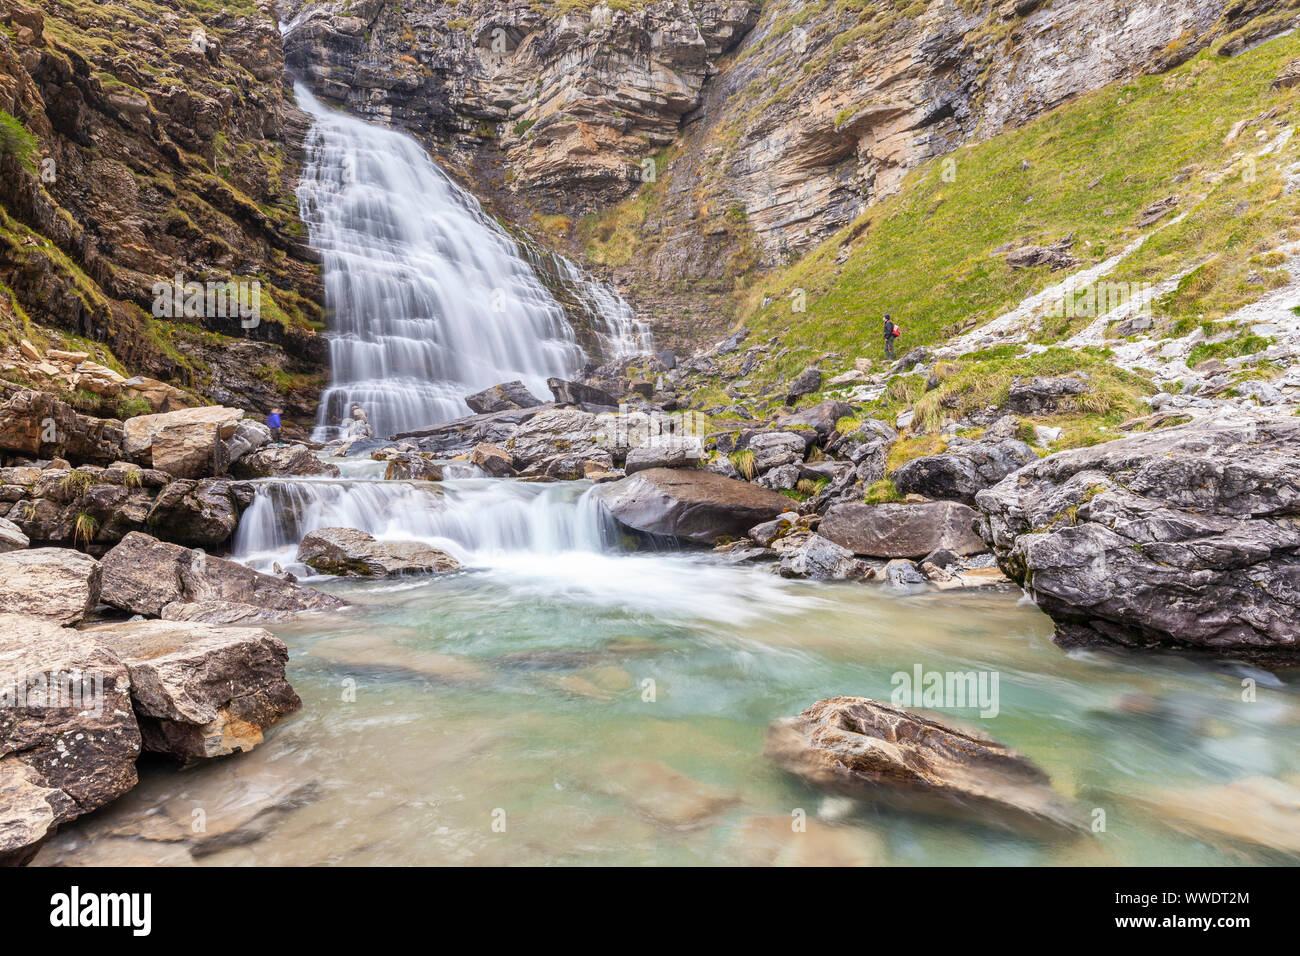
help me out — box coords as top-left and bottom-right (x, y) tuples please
(0, 614), (140, 865)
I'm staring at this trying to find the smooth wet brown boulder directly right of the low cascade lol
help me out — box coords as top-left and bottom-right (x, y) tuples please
(597, 468), (790, 544)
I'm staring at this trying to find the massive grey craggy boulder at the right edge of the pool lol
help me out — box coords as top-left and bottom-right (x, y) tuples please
(976, 419), (1300, 658)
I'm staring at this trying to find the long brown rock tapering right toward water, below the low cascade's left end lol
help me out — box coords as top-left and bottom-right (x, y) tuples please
(101, 532), (346, 618)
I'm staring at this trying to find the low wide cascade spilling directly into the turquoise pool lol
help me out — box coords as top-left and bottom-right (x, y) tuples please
(231, 476), (618, 570)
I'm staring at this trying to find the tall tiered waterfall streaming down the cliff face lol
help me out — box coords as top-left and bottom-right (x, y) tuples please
(294, 83), (649, 441)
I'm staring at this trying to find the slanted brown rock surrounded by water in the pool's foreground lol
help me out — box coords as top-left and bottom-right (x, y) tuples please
(763, 697), (1086, 836)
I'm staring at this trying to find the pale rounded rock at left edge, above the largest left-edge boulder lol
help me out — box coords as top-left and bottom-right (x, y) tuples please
(0, 548), (101, 624)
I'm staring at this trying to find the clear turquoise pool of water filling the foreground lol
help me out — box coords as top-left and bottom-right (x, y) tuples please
(42, 551), (1300, 865)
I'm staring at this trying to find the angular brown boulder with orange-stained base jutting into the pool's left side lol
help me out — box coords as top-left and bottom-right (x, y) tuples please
(88, 620), (303, 758)
